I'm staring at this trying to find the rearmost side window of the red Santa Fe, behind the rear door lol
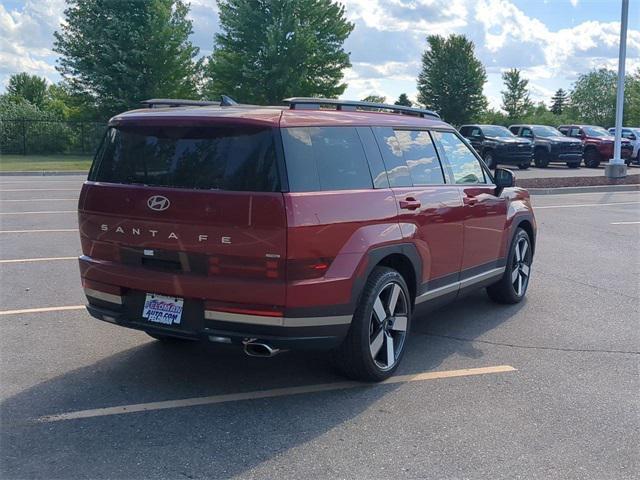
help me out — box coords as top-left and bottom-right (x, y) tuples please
(281, 127), (373, 192)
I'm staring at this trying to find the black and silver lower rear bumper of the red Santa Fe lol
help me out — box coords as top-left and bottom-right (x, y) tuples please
(85, 290), (351, 349)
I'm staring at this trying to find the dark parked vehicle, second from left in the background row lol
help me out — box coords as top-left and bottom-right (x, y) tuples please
(509, 125), (582, 168)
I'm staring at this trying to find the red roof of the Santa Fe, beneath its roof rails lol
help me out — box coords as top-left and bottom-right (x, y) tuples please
(109, 105), (453, 130)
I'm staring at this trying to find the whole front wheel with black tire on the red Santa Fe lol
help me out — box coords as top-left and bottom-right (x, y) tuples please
(487, 228), (533, 304)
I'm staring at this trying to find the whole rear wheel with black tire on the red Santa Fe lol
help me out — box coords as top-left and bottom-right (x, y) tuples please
(333, 267), (412, 382)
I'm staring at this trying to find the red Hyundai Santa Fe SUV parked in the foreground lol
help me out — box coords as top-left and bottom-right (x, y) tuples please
(79, 98), (536, 381)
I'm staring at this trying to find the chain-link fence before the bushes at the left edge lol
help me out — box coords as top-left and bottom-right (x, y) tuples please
(0, 119), (107, 155)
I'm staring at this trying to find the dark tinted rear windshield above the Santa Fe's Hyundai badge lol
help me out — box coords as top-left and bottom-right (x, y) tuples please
(89, 126), (280, 192)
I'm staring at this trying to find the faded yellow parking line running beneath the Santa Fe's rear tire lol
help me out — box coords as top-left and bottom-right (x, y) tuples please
(38, 365), (516, 422)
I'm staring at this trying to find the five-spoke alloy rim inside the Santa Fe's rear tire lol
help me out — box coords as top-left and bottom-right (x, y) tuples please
(369, 282), (409, 370)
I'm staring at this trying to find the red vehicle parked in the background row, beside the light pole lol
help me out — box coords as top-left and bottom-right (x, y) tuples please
(558, 125), (633, 168)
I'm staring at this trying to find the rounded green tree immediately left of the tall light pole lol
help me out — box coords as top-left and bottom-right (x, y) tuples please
(571, 68), (618, 127)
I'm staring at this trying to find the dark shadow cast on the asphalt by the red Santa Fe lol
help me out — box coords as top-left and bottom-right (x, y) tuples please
(0, 292), (523, 478)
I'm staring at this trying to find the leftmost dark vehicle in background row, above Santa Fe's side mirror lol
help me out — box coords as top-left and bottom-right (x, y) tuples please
(460, 125), (533, 170)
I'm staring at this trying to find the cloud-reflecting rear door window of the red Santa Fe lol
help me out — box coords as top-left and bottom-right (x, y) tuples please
(395, 130), (444, 185)
